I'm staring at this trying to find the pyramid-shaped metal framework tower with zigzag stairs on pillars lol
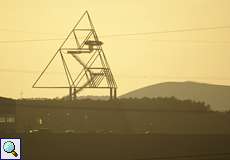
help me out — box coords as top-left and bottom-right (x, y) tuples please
(33, 11), (117, 100)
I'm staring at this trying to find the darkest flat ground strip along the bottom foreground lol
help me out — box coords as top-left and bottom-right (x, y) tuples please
(1, 134), (230, 160)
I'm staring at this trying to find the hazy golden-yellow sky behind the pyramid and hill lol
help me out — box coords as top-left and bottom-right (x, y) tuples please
(0, 0), (230, 98)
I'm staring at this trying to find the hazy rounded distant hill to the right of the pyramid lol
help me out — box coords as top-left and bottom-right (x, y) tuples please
(120, 81), (230, 111)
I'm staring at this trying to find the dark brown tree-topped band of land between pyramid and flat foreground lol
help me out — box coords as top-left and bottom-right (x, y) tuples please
(0, 98), (230, 134)
